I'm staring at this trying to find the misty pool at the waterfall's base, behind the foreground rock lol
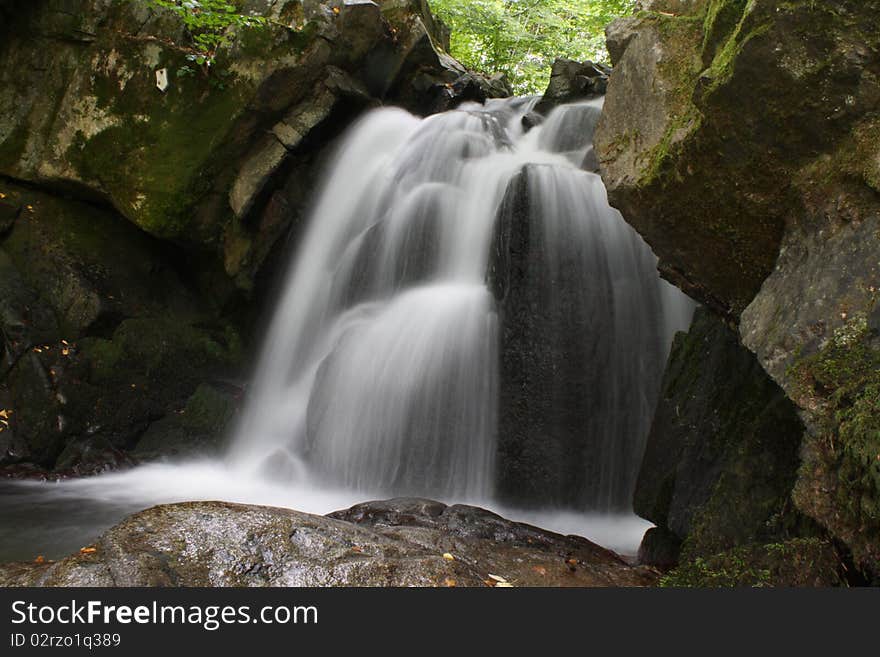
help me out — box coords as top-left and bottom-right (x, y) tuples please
(0, 461), (652, 562)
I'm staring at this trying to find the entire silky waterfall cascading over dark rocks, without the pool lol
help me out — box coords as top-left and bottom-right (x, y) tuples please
(228, 98), (692, 509)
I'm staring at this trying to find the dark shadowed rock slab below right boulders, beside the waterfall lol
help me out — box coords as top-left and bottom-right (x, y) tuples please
(634, 310), (806, 565)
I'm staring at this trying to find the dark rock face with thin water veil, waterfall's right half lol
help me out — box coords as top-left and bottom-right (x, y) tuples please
(489, 165), (665, 510)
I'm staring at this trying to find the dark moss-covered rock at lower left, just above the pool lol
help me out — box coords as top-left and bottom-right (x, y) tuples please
(1, 318), (239, 466)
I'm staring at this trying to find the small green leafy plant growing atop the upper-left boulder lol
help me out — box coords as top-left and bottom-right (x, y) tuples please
(146, 0), (266, 67)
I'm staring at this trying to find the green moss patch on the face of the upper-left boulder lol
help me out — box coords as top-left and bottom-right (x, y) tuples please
(67, 67), (247, 240)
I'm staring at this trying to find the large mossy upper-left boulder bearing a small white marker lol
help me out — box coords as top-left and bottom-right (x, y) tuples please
(0, 0), (498, 288)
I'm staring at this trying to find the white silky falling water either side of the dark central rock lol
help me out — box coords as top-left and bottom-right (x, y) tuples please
(229, 99), (691, 506)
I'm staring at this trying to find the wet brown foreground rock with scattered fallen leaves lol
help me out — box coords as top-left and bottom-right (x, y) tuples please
(0, 499), (656, 586)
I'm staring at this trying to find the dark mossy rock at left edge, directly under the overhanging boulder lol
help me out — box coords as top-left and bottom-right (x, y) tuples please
(0, 182), (201, 340)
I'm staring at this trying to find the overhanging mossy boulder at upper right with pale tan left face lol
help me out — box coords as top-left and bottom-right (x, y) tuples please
(596, 0), (880, 321)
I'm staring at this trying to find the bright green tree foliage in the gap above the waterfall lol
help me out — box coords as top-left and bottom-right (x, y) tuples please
(430, 0), (635, 93)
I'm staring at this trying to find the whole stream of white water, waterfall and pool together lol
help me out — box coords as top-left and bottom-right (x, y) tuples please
(0, 98), (693, 558)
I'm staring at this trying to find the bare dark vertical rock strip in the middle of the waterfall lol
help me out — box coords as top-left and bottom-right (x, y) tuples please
(490, 168), (610, 505)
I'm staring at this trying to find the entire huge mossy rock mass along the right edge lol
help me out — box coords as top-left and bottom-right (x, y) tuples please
(595, 0), (880, 574)
